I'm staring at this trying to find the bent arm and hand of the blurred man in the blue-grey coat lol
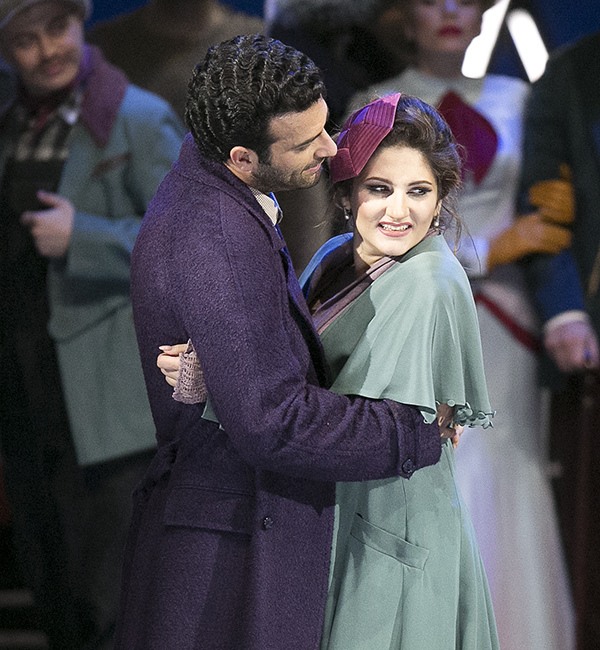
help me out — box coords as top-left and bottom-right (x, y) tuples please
(38, 98), (183, 282)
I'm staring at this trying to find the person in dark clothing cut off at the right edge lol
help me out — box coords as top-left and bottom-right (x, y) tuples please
(520, 31), (600, 650)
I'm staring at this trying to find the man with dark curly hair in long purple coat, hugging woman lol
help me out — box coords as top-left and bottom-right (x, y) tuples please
(116, 36), (454, 650)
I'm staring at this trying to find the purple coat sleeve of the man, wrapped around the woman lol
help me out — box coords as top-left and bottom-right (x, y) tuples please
(155, 187), (441, 481)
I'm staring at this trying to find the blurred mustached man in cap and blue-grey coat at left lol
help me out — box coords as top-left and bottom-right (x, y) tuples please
(0, 0), (183, 650)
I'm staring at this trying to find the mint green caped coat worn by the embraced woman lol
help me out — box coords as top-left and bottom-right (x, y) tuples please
(302, 237), (498, 650)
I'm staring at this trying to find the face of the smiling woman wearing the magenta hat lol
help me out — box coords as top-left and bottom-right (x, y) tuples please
(343, 146), (441, 266)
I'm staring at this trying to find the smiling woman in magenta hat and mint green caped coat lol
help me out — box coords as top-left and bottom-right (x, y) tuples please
(301, 94), (498, 650)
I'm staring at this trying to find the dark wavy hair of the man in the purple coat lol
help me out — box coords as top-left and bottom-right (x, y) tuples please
(185, 34), (325, 163)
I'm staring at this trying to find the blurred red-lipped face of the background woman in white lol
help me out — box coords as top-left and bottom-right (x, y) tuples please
(407, 0), (483, 58)
